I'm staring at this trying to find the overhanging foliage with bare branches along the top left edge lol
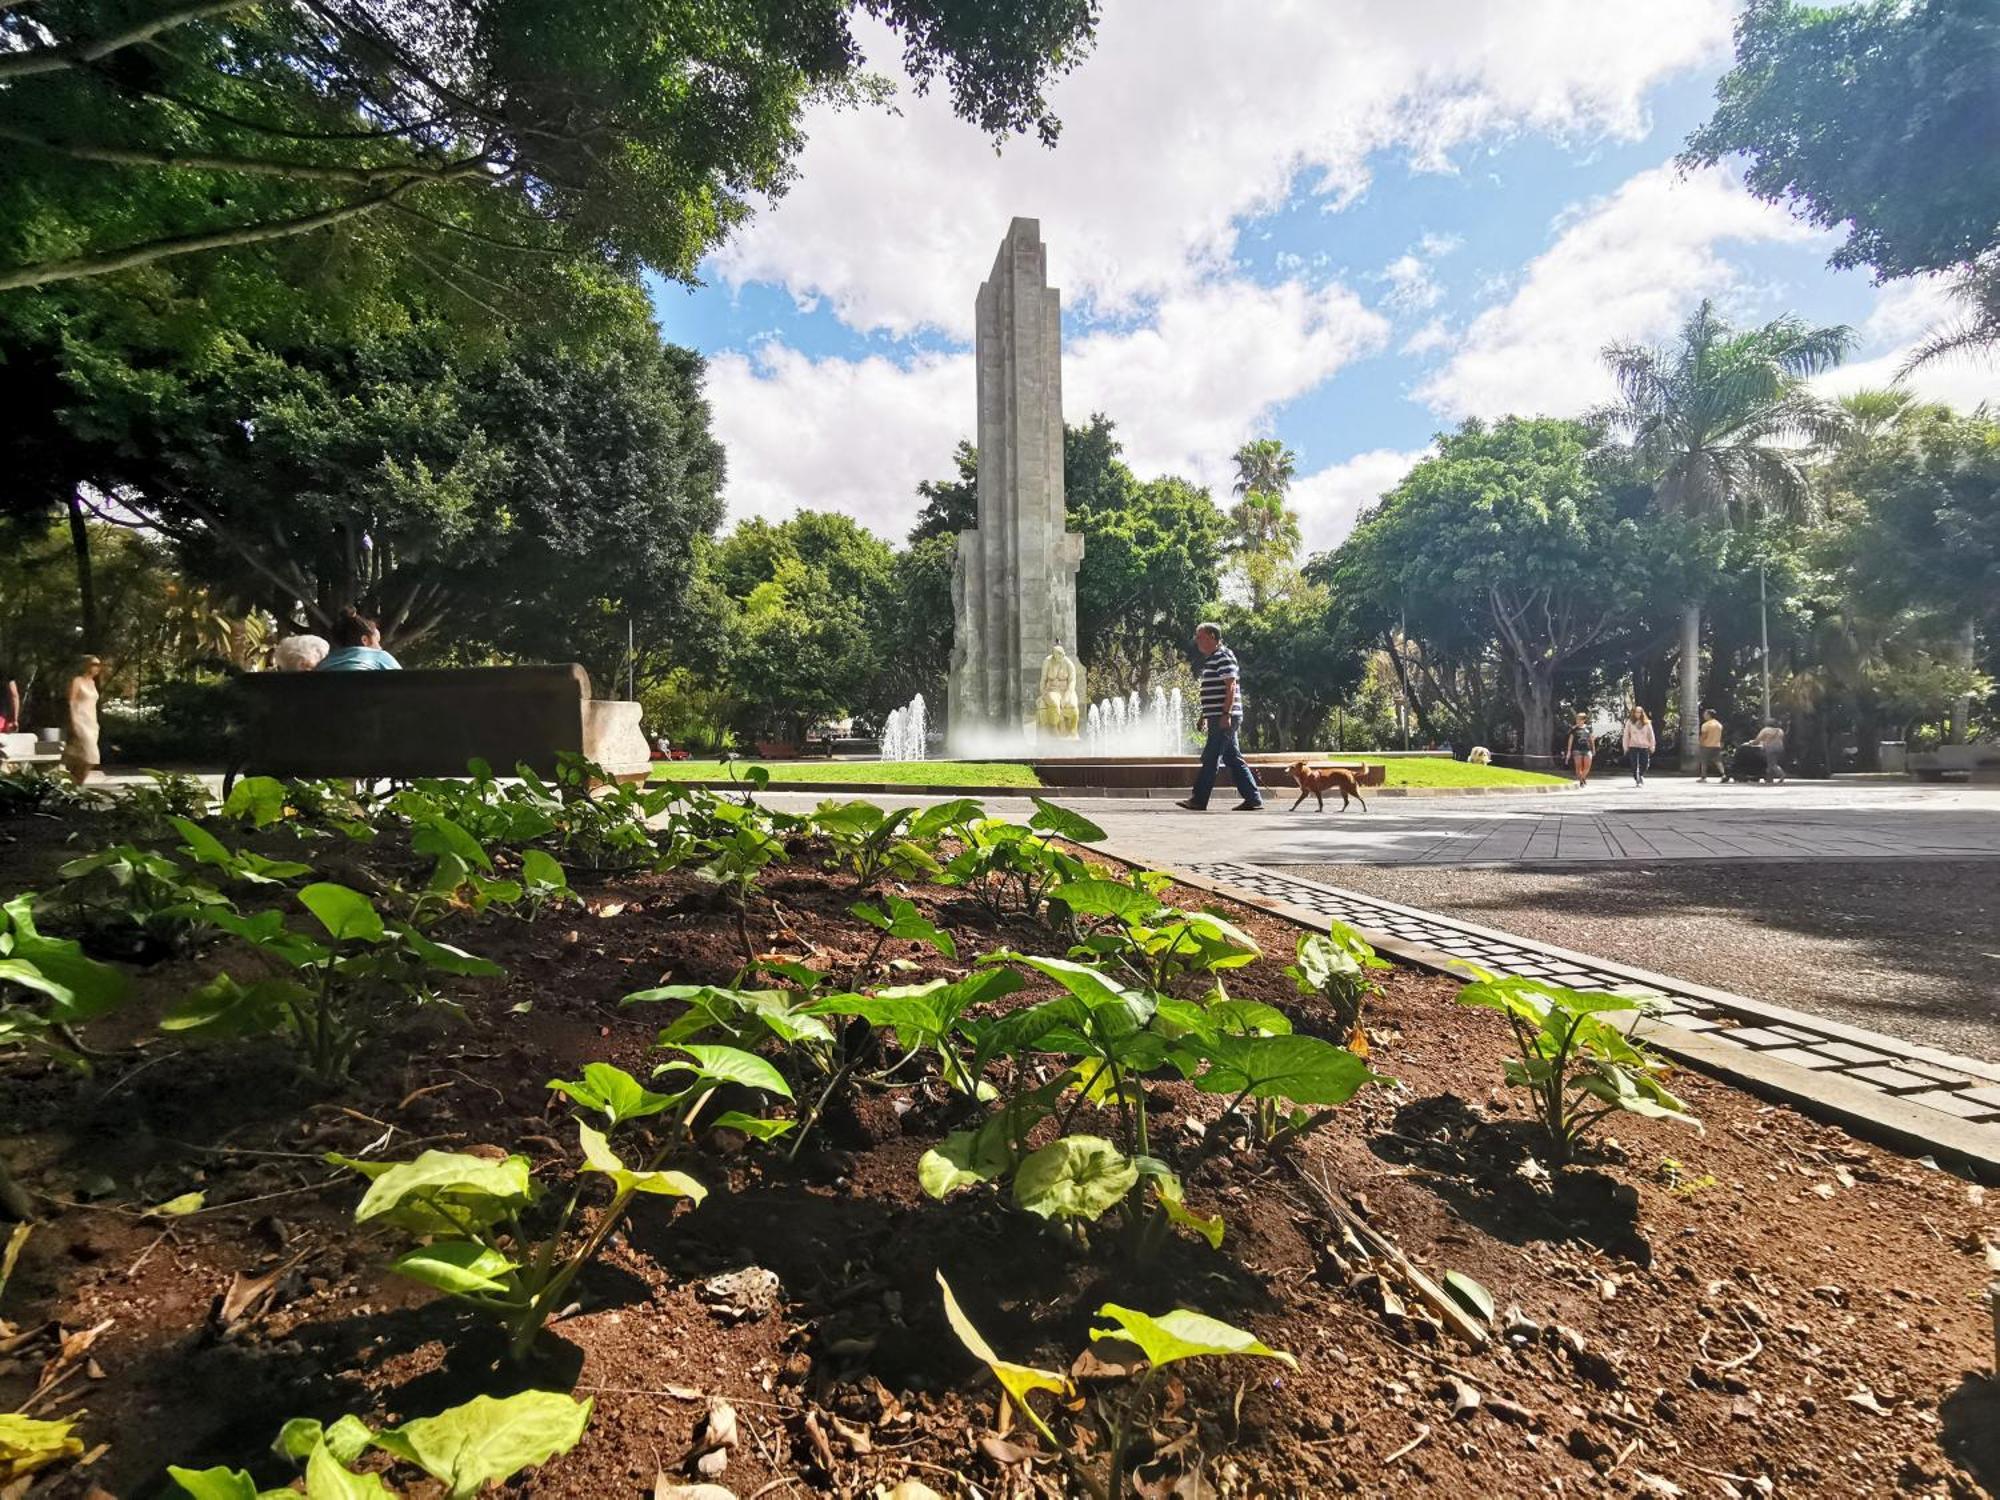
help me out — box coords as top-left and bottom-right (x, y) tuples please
(0, 0), (1096, 300)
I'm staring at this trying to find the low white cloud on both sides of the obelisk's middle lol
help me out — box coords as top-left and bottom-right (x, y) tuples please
(708, 282), (1388, 538)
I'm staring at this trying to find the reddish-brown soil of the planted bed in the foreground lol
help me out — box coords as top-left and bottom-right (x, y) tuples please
(0, 826), (2000, 1500)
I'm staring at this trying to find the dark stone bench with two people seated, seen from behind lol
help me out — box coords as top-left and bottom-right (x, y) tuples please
(230, 662), (652, 782)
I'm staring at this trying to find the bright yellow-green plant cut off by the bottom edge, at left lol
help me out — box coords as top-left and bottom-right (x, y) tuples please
(166, 1390), (594, 1500)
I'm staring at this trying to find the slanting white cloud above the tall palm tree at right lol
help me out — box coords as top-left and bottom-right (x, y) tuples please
(1416, 166), (1826, 418)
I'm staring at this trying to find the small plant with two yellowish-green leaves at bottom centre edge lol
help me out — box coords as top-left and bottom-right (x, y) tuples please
(938, 1270), (1298, 1500)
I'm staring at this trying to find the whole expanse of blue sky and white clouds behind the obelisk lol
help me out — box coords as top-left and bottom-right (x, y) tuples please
(654, 0), (2000, 546)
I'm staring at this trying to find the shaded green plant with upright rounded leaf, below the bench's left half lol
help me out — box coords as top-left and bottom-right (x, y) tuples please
(160, 880), (502, 1082)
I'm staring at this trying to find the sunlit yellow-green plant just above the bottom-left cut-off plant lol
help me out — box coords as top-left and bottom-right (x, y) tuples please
(328, 1048), (720, 1360)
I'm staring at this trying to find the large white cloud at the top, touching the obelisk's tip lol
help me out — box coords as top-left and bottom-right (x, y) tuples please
(712, 0), (1730, 338)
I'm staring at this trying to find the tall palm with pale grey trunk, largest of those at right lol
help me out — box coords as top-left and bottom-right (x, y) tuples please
(1596, 298), (1854, 752)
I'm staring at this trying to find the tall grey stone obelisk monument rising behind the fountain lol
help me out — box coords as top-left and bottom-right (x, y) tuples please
(950, 218), (1084, 754)
